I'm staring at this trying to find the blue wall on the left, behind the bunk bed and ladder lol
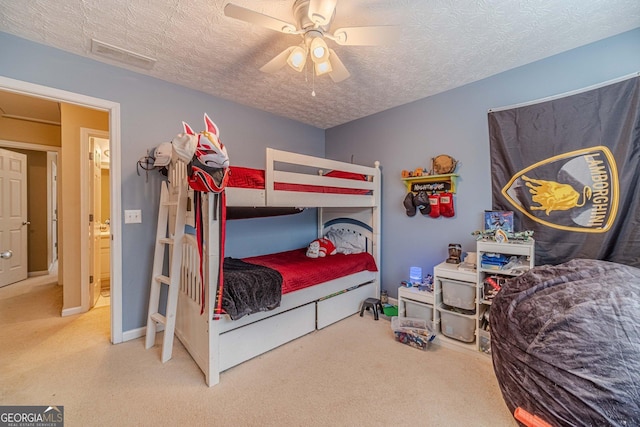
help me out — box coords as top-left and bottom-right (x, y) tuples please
(0, 32), (324, 331)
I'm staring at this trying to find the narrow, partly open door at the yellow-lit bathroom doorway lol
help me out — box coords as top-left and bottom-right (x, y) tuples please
(89, 138), (102, 307)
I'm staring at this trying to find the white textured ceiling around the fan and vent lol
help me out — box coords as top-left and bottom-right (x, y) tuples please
(0, 0), (640, 129)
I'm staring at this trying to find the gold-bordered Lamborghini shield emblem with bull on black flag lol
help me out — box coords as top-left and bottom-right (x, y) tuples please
(501, 146), (620, 233)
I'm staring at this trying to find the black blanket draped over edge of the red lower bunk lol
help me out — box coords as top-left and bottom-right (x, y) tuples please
(222, 258), (282, 320)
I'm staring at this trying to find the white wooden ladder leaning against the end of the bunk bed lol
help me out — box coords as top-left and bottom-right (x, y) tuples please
(145, 181), (187, 363)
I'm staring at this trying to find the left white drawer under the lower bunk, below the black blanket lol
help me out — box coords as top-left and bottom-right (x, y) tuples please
(219, 303), (316, 371)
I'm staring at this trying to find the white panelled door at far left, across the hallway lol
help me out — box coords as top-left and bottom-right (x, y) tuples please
(0, 149), (29, 287)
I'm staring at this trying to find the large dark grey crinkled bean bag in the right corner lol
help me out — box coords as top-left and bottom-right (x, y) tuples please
(490, 259), (640, 427)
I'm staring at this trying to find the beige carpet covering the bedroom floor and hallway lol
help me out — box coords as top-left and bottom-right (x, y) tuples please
(0, 284), (517, 427)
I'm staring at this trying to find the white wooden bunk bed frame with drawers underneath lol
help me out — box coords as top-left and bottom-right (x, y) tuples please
(169, 148), (381, 386)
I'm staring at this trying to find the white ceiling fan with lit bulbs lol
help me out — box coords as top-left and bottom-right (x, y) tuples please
(224, 0), (398, 83)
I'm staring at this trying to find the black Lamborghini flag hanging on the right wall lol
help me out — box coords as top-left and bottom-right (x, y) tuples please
(489, 75), (640, 267)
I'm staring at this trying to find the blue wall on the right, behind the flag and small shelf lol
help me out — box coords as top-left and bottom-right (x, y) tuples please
(325, 29), (640, 296)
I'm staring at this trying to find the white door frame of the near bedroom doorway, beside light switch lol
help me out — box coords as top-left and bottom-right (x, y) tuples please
(0, 76), (122, 344)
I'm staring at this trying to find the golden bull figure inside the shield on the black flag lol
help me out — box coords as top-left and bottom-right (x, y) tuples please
(522, 175), (591, 215)
